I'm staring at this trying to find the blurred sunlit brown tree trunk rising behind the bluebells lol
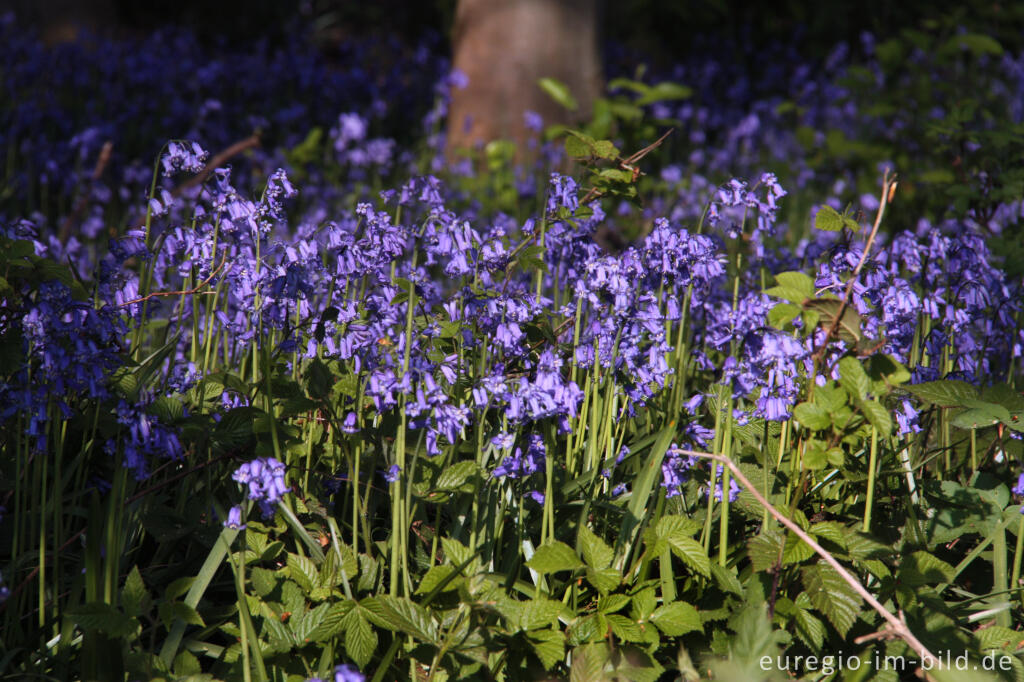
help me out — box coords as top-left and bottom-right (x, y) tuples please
(447, 0), (602, 156)
